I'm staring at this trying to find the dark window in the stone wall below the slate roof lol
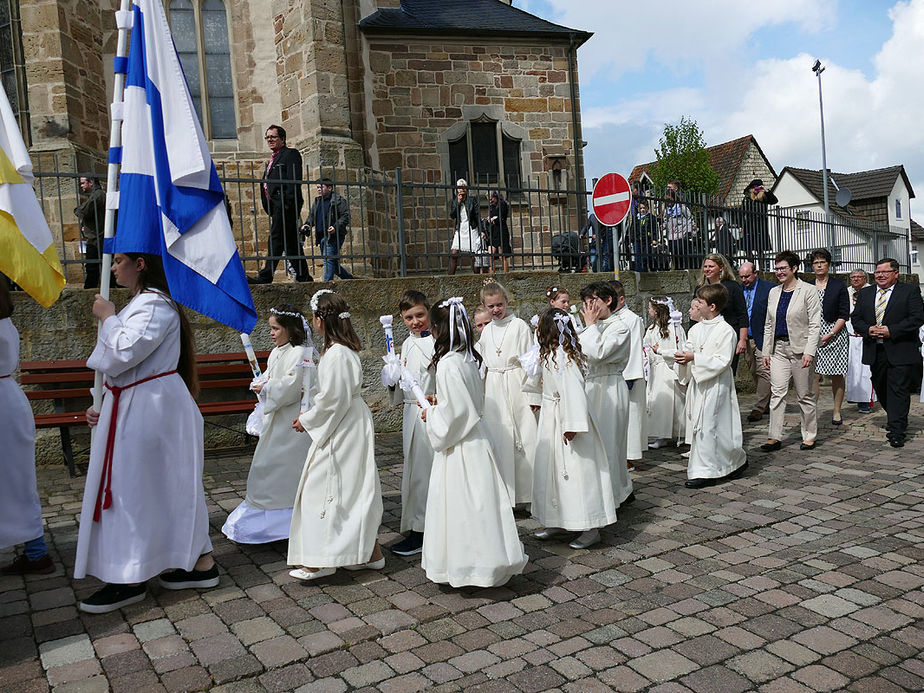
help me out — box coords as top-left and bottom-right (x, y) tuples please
(449, 119), (522, 189)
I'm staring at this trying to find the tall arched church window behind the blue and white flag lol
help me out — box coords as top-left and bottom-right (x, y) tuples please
(168, 0), (237, 140)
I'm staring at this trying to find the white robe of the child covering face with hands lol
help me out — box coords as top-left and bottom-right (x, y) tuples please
(578, 314), (632, 505)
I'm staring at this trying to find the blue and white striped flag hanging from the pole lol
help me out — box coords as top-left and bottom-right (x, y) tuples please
(113, 0), (257, 332)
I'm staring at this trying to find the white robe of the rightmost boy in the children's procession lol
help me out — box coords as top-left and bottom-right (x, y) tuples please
(674, 315), (747, 479)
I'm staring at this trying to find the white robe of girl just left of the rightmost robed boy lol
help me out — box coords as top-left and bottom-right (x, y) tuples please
(644, 322), (687, 441)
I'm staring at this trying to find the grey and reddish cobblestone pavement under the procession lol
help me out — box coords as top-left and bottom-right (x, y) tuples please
(0, 396), (924, 693)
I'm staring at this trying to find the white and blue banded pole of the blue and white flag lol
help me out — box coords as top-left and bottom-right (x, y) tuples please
(91, 0), (132, 414)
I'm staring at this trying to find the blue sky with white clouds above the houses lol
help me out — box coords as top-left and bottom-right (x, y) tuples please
(513, 0), (924, 211)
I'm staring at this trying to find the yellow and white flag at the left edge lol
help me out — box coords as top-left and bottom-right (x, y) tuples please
(0, 87), (65, 308)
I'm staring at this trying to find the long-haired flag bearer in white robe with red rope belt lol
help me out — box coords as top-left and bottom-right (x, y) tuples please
(74, 253), (218, 613)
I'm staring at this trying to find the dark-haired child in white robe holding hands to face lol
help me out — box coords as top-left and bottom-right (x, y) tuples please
(579, 282), (635, 506)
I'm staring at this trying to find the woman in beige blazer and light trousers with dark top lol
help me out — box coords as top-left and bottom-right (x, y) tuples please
(760, 250), (821, 452)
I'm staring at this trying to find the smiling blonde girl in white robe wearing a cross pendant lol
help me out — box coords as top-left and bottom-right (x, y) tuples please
(476, 281), (541, 505)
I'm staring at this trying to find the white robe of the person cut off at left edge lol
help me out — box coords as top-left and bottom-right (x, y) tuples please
(0, 318), (45, 549)
